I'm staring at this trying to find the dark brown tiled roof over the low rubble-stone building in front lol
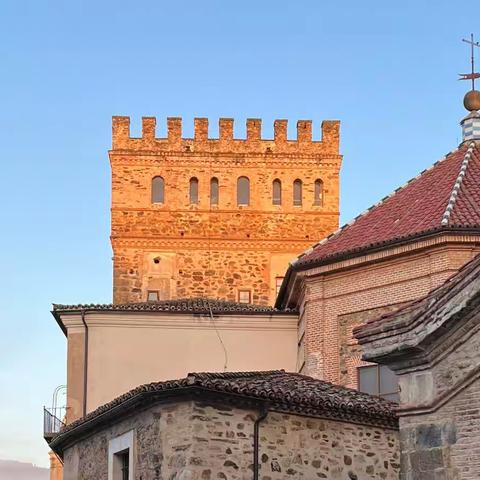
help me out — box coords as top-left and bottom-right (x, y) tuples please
(50, 370), (398, 451)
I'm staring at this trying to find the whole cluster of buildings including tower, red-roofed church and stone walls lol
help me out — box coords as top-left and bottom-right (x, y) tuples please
(46, 53), (480, 480)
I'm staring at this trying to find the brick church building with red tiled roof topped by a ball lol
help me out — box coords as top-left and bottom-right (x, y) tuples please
(276, 92), (480, 390)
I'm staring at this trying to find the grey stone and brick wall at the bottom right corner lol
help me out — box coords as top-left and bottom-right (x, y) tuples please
(399, 310), (480, 480)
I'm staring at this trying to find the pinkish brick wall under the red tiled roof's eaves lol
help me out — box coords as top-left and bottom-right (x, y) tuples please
(299, 243), (479, 387)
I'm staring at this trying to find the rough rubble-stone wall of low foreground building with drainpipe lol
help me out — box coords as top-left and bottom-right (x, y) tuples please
(64, 401), (399, 480)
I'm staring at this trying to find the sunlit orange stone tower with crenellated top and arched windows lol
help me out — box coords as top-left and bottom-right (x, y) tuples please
(109, 117), (342, 304)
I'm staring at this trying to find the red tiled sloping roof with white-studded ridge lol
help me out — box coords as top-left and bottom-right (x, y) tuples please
(293, 142), (480, 269)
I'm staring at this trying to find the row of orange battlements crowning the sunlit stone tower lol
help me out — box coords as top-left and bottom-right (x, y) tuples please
(112, 116), (340, 155)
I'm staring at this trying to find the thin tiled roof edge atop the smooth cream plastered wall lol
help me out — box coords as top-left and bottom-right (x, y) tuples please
(53, 298), (292, 314)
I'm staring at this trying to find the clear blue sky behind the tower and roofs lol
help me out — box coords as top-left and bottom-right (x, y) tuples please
(0, 0), (480, 466)
